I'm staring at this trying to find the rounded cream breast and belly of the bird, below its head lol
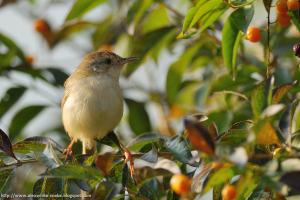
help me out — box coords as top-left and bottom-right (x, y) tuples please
(63, 83), (123, 139)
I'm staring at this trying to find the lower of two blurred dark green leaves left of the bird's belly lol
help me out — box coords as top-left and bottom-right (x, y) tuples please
(9, 105), (45, 140)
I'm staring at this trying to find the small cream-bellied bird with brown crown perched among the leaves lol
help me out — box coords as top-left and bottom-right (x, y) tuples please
(61, 51), (136, 156)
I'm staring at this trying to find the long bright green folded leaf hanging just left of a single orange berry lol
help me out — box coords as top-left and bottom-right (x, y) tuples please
(222, 7), (254, 79)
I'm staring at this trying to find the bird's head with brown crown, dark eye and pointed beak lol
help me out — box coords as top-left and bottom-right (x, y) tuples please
(78, 51), (137, 78)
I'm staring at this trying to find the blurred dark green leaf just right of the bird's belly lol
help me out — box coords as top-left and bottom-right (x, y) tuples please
(125, 99), (151, 135)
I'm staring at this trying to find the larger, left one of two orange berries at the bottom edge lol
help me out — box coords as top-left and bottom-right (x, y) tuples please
(170, 174), (192, 195)
